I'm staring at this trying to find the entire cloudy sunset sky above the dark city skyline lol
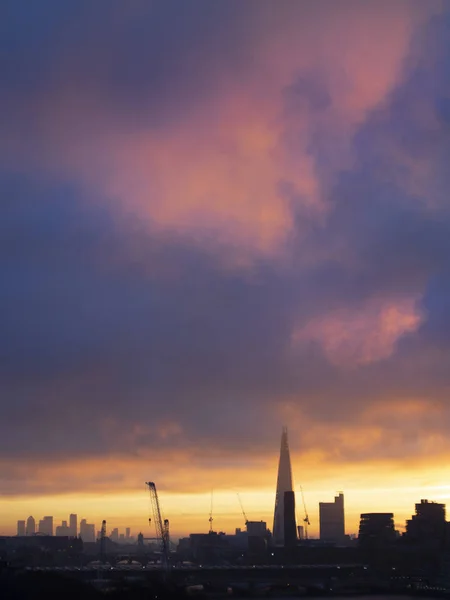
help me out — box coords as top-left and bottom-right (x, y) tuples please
(0, 0), (450, 535)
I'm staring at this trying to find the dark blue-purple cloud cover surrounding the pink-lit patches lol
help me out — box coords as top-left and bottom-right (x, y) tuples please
(0, 2), (450, 496)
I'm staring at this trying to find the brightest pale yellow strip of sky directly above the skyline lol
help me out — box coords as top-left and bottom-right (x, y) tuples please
(0, 454), (450, 538)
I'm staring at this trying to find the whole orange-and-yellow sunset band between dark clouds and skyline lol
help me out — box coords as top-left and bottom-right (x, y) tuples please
(4, 440), (450, 536)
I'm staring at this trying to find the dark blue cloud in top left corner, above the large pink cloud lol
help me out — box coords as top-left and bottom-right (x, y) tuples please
(0, 0), (264, 137)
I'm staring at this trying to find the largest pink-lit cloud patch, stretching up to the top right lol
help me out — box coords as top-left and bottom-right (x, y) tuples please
(0, 1), (438, 256)
